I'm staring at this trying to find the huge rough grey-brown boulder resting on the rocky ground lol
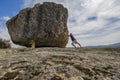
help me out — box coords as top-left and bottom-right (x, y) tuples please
(6, 2), (68, 47)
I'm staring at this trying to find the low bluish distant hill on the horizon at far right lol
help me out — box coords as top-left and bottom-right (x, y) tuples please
(86, 43), (120, 48)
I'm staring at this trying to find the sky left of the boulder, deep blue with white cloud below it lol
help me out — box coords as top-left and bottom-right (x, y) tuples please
(0, 0), (23, 40)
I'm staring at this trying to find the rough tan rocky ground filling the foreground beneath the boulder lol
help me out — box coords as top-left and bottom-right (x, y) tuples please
(0, 48), (120, 80)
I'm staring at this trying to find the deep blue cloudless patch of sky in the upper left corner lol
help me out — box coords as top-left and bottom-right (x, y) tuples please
(0, 0), (23, 17)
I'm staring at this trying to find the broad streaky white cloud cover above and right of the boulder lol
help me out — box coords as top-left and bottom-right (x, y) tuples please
(23, 0), (120, 46)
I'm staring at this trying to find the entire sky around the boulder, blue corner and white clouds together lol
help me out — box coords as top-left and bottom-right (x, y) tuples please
(0, 0), (120, 47)
